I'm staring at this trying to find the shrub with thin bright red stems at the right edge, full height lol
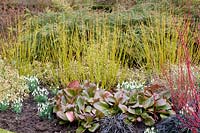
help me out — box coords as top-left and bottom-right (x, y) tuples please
(165, 10), (200, 133)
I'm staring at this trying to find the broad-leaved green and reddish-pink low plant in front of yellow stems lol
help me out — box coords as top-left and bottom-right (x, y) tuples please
(54, 81), (173, 132)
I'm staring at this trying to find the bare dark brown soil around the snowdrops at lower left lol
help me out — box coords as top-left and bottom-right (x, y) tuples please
(0, 97), (77, 133)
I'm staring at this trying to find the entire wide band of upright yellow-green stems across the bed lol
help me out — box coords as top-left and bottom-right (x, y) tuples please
(2, 6), (200, 88)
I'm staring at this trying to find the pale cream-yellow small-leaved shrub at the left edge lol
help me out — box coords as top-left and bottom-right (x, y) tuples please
(0, 57), (28, 102)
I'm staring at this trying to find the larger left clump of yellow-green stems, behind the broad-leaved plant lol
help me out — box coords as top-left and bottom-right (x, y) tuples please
(2, 13), (137, 87)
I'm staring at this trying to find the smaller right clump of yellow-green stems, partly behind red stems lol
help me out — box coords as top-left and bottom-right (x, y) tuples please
(140, 16), (200, 73)
